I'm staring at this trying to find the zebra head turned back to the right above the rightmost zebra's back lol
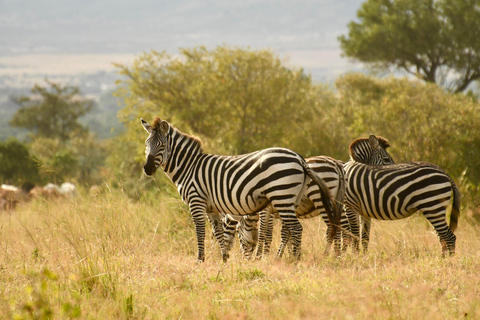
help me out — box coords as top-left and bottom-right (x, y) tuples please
(349, 134), (395, 165)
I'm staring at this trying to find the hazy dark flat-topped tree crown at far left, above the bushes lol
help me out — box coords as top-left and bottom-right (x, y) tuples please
(9, 80), (93, 141)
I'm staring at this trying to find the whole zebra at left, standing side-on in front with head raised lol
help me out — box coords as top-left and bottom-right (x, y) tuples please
(141, 117), (339, 262)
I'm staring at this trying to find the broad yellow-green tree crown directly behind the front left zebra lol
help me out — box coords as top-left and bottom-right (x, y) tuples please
(117, 46), (338, 156)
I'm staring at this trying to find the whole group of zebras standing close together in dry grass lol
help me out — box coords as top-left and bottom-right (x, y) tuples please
(141, 117), (460, 262)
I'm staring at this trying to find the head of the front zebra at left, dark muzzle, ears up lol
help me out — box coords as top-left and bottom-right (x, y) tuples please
(141, 117), (170, 176)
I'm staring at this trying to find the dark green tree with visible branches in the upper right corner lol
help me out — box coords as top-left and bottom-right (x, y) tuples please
(339, 0), (480, 92)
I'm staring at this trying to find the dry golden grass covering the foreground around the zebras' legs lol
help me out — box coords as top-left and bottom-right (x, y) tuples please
(0, 191), (480, 319)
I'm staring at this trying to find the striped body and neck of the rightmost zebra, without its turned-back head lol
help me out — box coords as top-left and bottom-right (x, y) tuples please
(344, 137), (461, 255)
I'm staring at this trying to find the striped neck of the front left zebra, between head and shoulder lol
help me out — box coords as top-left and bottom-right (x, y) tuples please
(163, 132), (203, 186)
